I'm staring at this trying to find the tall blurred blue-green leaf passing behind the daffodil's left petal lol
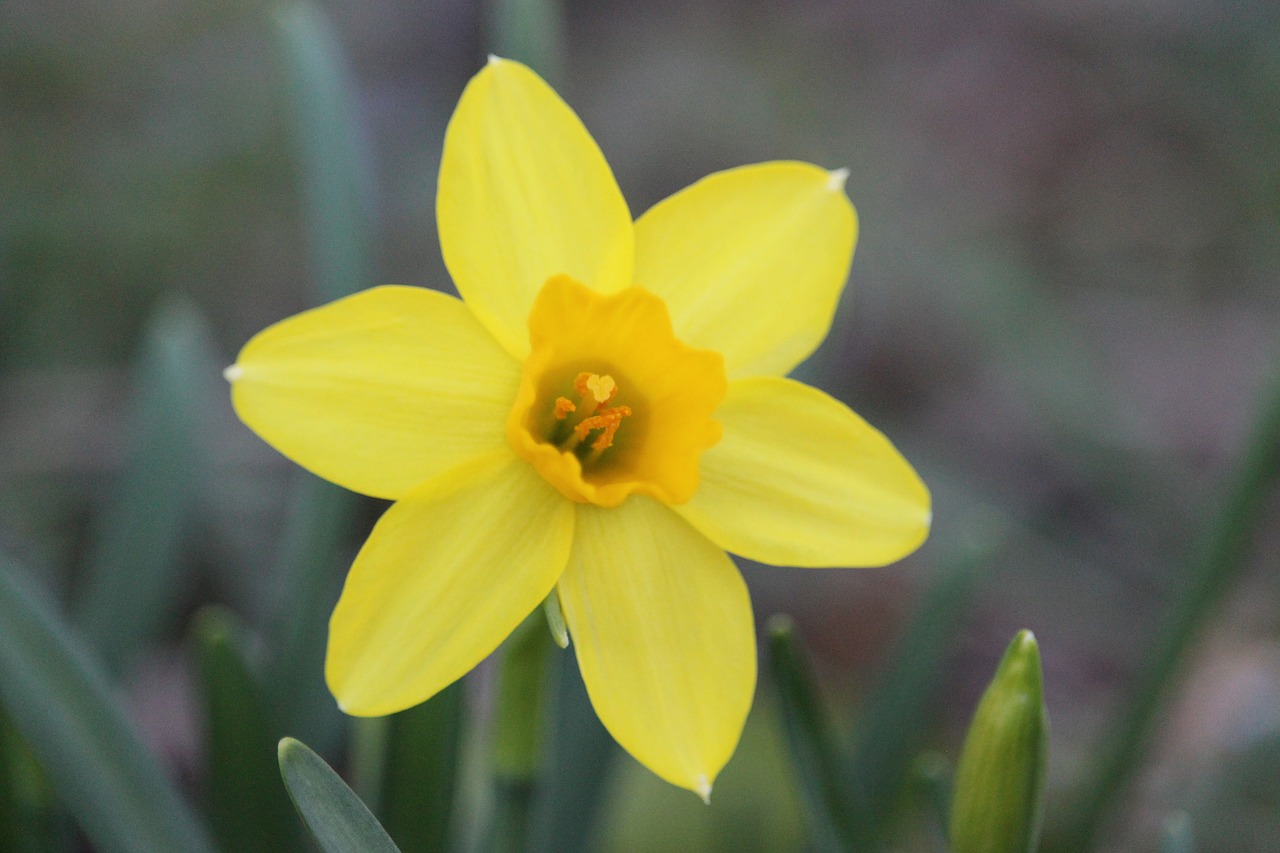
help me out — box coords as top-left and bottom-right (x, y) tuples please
(265, 0), (375, 752)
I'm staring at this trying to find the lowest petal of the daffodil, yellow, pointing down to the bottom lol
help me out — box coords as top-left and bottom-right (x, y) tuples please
(559, 496), (755, 798)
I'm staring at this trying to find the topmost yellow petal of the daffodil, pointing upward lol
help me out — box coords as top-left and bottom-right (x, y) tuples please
(436, 59), (632, 357)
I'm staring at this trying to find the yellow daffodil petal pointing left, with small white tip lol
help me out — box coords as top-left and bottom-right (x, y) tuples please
(227, 286), (520, 500)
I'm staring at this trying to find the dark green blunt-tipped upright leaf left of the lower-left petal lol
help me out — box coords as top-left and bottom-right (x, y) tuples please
(193, 607), (301, 853)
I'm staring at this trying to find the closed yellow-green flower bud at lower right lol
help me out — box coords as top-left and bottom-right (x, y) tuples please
(950, 630), (1048, 853)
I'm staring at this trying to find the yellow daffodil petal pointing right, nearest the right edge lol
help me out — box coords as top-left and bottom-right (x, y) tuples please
(675, 377), (932, 567)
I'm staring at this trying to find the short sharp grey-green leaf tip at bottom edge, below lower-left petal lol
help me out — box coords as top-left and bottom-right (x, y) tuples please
(279, 738), (399, 853)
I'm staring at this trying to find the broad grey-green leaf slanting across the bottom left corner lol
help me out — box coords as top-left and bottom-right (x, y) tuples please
(0, 556), (214, 853)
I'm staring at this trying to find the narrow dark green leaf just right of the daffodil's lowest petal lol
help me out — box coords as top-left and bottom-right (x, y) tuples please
(765, 616), (856, 850)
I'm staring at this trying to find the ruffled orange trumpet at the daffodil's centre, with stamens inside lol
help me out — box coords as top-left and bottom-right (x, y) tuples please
(507, 275), (726, 506)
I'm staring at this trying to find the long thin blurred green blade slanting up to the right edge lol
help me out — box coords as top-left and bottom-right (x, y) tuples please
(1055, 363), (1280, 850)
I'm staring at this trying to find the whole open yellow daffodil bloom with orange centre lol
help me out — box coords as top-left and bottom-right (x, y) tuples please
(228, 59), (929, 797)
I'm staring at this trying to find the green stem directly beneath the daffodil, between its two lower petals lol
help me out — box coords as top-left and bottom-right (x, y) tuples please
(486, 607), (552, 853)
